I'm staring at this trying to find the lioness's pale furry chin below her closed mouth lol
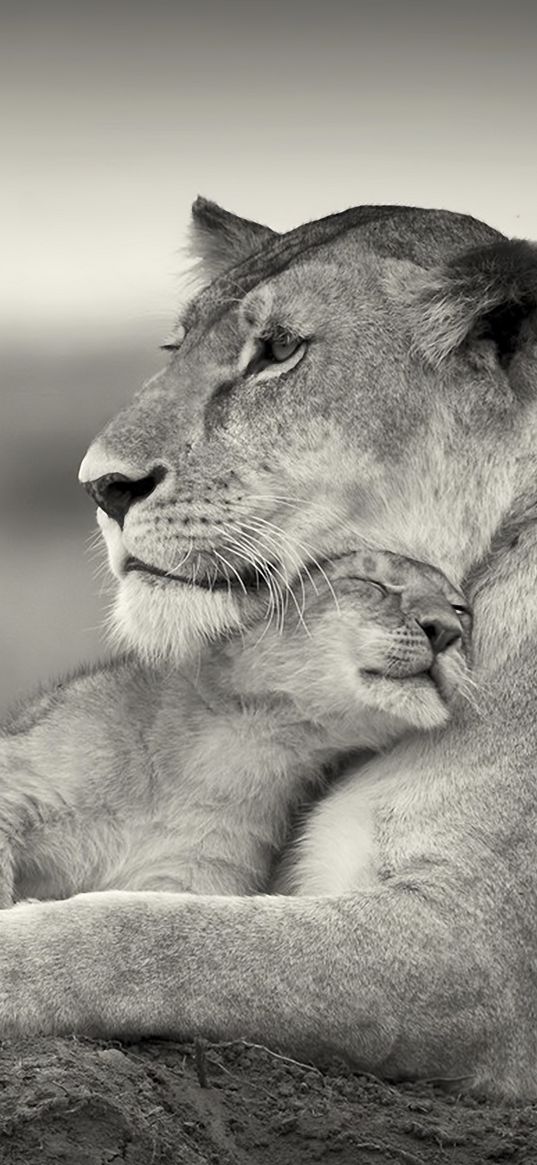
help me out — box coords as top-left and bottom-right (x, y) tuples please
(113, 576), (242, 663)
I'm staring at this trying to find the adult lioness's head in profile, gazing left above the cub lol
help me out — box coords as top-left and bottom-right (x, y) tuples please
(80, 200), (537, 656)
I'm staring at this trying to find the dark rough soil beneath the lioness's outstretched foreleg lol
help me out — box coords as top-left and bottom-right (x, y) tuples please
(0, 1038), (537, 1165)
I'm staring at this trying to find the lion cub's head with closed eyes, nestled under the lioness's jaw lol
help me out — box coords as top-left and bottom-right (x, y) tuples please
(236, 550), (471, 748)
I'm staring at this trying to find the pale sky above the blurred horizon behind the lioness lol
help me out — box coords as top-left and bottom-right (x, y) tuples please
(0, 0), (537, 339)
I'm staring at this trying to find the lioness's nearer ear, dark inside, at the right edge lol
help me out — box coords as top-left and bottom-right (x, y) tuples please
(411, 239), (537, 368)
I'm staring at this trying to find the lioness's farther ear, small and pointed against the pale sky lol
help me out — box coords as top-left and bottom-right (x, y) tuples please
(189, 196), (276, 278)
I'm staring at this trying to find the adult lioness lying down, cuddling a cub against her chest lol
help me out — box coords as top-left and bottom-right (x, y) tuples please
(0, 200), (537, 1095)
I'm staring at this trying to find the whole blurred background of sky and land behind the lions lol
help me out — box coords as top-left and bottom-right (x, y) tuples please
(0, 0), (537, 709)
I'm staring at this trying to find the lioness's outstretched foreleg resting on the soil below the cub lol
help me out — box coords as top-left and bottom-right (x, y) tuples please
(0, 887), (507, 1087)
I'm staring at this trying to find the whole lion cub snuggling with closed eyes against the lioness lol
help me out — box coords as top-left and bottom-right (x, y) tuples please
(0, 551), (467, 905)
